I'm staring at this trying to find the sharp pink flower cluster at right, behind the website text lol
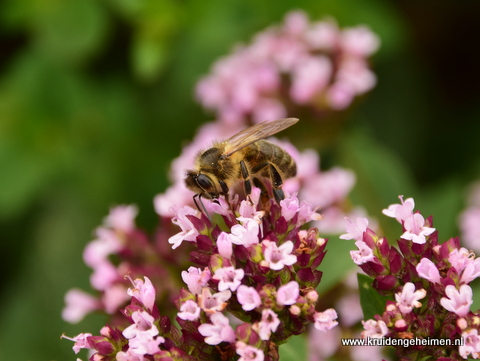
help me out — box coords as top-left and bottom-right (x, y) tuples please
(341, 197), (480, 361)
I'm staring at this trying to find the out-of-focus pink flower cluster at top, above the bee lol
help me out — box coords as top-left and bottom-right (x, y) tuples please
(196, 11), (380, 124)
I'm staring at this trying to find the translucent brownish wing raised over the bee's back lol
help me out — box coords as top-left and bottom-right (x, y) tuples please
(223, 118), (298, 157)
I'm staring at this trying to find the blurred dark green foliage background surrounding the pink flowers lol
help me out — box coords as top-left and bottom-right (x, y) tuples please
(0, 0), (480, 361)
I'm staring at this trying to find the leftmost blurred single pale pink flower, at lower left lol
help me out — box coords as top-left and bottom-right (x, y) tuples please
(62, 288), (100, 323)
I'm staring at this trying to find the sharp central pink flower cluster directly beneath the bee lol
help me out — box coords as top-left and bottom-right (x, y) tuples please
(169, 188), (337, 360)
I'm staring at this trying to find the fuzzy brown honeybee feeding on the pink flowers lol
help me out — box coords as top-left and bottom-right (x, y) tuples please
(185, 118), (298, 213)
